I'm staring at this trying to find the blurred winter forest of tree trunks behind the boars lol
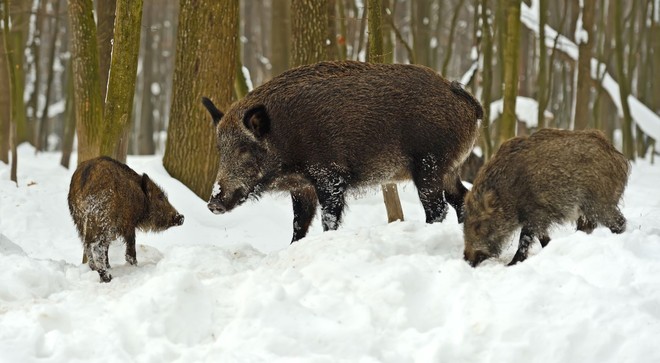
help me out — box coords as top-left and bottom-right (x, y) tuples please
(0, 0), (660, 191)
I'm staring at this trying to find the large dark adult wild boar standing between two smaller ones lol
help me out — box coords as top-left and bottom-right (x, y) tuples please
(203, 61), (482, 241)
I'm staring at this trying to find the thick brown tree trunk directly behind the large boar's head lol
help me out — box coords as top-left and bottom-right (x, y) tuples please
(163, 0), (238, 199)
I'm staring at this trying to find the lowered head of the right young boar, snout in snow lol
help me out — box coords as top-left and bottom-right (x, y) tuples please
(463, 190), (511, 267)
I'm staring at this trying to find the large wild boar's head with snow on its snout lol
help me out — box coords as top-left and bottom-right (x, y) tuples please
(202, 97), (273, 214)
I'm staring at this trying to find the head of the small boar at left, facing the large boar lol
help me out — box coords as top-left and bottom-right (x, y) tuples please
(138, 174), (184, 232)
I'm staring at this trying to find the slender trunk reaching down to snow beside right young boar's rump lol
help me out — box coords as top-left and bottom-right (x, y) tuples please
(614, 0), (635, 160)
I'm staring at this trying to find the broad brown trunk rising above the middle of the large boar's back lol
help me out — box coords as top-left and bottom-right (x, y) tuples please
(290, 0), (328, 67)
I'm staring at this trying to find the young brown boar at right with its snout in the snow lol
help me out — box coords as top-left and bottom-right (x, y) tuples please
(463, 129), (630, 266)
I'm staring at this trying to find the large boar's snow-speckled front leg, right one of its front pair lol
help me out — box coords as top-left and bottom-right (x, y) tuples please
(314, 172), (348, 231)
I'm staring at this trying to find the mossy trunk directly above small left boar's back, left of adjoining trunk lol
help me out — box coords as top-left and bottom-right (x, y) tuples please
(68, 0), (103, 164)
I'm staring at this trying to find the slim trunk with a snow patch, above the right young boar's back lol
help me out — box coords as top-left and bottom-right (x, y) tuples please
(573, 0), (595, 130)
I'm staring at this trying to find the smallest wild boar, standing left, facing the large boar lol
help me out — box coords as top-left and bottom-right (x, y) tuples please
(68, 157), (183, 282)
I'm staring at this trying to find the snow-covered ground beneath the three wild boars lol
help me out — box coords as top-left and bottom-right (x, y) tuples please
(0, 145), (660, 363)
